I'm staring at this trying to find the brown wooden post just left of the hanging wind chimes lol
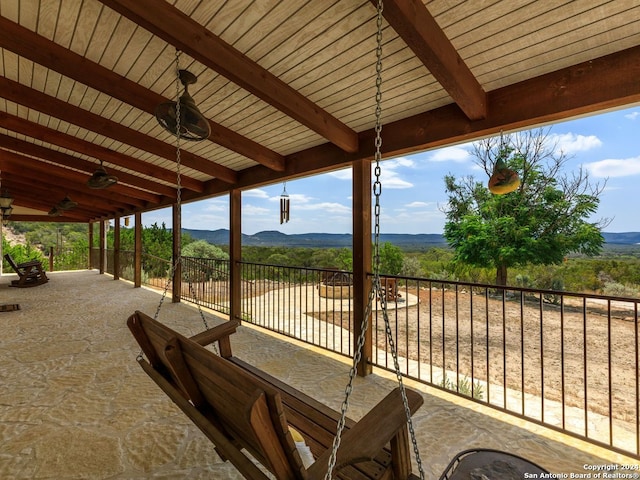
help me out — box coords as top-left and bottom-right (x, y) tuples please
(229, 190), (242, 322)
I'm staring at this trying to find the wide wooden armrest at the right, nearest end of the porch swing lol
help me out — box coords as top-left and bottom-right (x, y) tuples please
(308, 387), (424, 480)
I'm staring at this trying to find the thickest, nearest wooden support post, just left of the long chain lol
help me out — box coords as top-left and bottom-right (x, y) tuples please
(352, 159), (373, 377)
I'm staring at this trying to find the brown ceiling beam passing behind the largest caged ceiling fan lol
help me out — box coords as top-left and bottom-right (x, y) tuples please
(0, 17), (284, 174)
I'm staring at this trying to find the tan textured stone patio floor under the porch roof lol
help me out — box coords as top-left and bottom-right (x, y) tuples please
(0, 271), (639, 480)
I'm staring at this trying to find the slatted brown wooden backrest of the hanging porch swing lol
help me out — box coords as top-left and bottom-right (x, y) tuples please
(128, 312), (306, 480)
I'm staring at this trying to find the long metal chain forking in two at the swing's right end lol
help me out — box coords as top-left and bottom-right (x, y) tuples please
(324, 0), (425, 480)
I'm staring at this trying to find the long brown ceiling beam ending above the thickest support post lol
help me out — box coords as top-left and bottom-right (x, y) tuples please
(100, 0), (358, 152)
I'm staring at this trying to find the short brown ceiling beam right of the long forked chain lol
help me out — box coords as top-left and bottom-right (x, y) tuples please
(371, 0), (487, 120)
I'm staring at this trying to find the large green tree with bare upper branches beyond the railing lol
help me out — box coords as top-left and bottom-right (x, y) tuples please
(444, 130), (608, 285)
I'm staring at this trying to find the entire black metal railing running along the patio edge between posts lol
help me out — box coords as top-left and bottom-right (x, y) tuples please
(86, 251), (640, 458)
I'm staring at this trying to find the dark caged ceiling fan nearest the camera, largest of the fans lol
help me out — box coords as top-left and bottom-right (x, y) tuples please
(156, 70), (211, 142)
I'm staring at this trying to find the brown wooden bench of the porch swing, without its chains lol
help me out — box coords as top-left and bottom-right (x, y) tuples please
(127, 311), (424, 480)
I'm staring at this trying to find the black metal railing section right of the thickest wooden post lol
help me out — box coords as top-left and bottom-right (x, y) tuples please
(373, 277), (640, 457)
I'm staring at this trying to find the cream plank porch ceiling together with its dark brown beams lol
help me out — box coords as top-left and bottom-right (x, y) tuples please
(0, 0), (640, 222)
